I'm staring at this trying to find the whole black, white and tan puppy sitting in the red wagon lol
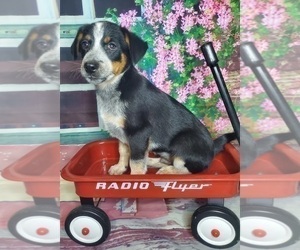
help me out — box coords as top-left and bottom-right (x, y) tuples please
(71, 22), (235, 175)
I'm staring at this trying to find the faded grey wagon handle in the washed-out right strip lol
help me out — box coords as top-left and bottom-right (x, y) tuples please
(241, 42), (300, 145)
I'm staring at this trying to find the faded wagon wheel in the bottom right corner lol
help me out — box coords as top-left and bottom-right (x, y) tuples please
(241, 205), (300, 249)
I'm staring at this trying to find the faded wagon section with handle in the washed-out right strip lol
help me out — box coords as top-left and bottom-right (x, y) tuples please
(240, 42), (300, 249)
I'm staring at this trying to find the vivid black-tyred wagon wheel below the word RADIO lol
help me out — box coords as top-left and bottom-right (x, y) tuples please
(65, 205), (110, 246)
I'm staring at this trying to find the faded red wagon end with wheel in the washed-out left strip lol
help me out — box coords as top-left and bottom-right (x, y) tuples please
(2, 142), (60, 246)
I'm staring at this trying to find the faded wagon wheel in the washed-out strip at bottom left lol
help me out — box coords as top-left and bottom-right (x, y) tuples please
(8, 206), (60, 246)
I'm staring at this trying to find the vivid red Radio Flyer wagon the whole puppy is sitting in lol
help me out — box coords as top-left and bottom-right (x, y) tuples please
(61, 43), (240, 249)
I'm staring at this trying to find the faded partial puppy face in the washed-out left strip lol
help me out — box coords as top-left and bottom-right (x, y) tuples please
(18, 23), (60, 84)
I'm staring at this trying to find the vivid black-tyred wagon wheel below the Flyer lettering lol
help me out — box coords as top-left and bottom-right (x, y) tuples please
(191, 205), (240, 249)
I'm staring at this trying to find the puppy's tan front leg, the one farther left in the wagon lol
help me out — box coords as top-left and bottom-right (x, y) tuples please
(108, 141), (130, 175)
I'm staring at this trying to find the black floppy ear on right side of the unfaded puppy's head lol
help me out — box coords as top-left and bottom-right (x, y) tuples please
(121, 28), (148, 64)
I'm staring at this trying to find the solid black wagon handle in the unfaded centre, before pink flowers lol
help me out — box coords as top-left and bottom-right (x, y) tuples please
(201, 42), (240, 143)
